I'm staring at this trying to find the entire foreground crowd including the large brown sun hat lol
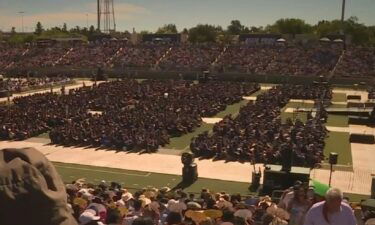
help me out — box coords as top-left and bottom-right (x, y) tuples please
(0, 148), (360, 225)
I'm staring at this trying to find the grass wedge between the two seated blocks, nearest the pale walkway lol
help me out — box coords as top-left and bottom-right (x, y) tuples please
(164, 123), (214, 150)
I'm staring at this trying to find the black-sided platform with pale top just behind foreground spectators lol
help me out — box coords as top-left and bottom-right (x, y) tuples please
(262, 165), (310, 195)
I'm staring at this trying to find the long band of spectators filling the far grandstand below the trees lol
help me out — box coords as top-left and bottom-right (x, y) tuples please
(0, 42), (375, 76)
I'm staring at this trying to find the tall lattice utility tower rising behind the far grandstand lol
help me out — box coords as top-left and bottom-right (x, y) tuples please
(97, 0), (116, 34)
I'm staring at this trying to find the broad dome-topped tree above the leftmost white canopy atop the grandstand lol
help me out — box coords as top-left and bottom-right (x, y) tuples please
(266, 18), (313, 36)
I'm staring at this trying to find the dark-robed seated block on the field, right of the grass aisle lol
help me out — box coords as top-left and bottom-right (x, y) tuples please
(190, 85), (331, 167)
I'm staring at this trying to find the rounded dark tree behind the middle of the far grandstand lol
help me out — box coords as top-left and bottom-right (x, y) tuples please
(189, 24), (223, 43)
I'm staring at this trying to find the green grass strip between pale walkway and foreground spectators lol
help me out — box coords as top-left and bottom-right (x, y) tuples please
(53, 163), (250, 195)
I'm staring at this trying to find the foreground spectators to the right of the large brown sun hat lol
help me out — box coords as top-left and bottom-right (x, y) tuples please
(61, 180), (357, 225)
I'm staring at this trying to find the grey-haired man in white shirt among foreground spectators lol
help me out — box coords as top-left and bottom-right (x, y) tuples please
(304, 188), (357, 225)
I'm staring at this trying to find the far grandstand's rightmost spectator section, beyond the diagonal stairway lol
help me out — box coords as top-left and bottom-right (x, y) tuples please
(335, 48), (375, 77)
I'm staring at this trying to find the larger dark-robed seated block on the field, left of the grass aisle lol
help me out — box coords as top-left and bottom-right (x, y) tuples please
(0, 80), (259, 152)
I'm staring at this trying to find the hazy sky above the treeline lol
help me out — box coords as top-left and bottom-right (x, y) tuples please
(0, 0), (375, 31)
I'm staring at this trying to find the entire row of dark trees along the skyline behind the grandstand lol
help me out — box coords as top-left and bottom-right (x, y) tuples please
(2, 17), (375, 46)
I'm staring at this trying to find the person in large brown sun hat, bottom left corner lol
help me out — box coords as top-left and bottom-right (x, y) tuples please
(0, 148), (77, 225)
